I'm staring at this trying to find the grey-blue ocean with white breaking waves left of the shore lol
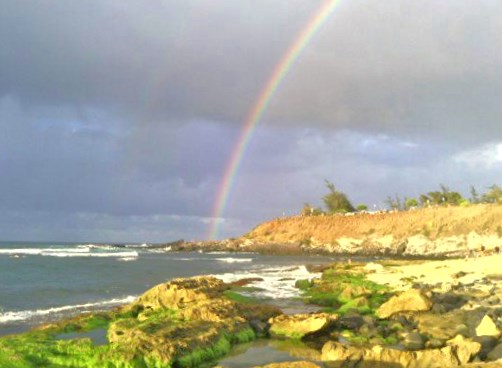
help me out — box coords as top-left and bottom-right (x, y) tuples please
(0, 242), (333, 335)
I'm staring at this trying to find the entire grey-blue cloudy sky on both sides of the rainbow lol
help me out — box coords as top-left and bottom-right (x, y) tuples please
(0, 0), (502, 242)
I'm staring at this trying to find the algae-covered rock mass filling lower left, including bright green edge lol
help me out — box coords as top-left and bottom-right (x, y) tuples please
(0, 277), (280, 368)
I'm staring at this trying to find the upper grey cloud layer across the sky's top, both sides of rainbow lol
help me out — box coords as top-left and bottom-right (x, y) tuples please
(0, 0), (502, 143)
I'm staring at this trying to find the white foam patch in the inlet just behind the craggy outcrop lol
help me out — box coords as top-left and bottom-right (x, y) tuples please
(214, 266), (320, 299)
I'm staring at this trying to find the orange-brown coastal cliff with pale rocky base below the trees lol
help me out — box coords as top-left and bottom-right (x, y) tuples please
(177, 204), (502, 257)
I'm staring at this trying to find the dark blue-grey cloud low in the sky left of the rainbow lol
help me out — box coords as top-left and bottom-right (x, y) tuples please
(0, 98), (227, 220)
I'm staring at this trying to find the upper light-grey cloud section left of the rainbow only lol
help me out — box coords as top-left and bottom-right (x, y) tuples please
(0, 1), (316, 120)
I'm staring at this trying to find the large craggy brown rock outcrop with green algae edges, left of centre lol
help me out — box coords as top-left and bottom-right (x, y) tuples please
(108, 277), (279, 366)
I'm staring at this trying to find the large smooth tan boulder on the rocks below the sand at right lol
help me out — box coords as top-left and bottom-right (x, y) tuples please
(376, 289), (432, 318)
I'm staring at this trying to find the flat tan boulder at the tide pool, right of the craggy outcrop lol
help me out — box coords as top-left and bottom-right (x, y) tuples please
(268, 313), (338, 339)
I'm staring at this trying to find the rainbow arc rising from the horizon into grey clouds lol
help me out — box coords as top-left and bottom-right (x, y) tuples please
(207, 0), (341, 239)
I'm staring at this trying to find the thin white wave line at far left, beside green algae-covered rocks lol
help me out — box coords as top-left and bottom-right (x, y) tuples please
(0, 295), (137, 324)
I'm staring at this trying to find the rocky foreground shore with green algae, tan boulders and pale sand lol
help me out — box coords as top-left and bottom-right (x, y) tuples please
(0, 255), (502, 368)
